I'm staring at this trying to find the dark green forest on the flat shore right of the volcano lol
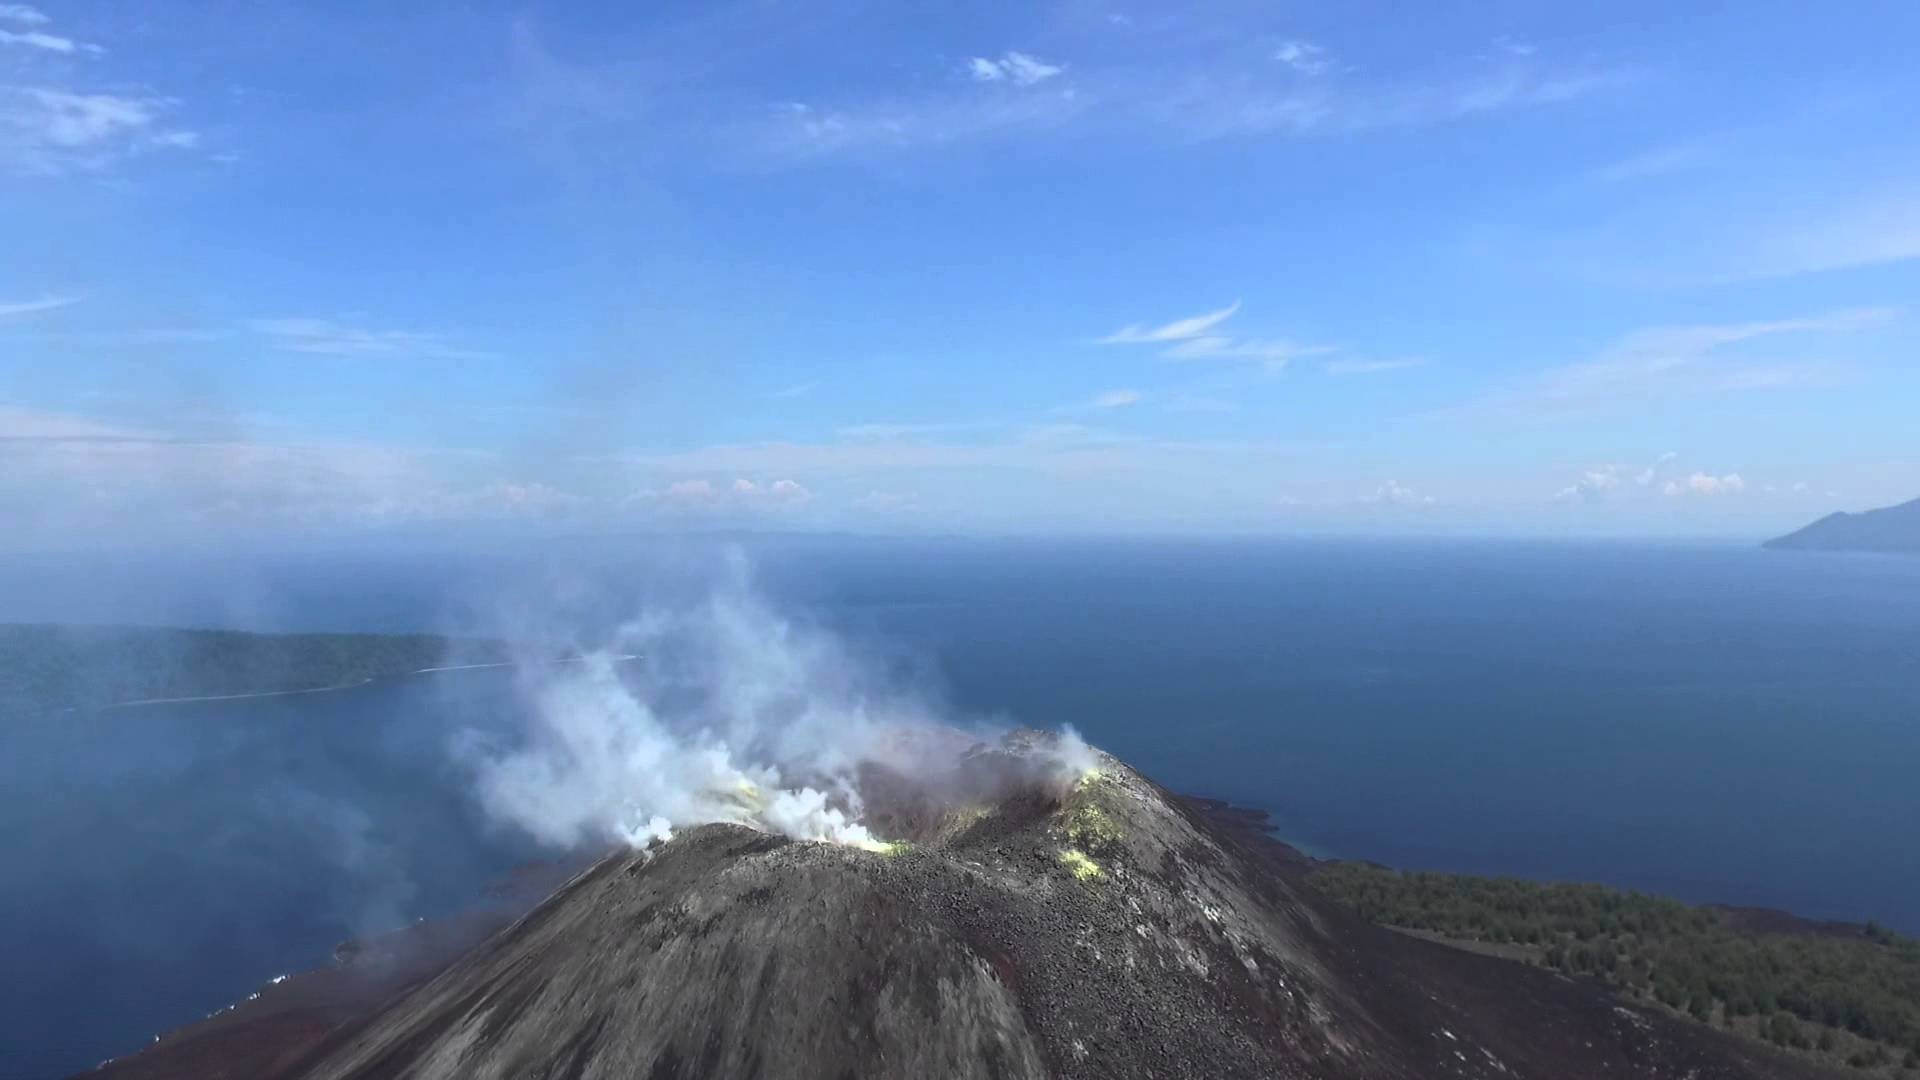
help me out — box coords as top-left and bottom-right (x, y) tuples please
(1313, 863), (1920, 1068)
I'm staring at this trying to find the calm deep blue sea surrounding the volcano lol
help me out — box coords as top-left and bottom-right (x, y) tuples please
(0, 538), (1920, 1076)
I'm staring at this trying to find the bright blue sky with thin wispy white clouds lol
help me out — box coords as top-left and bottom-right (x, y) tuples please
(0, 0), (1920, 548)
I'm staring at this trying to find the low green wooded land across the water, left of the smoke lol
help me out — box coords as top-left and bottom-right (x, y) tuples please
(0, 625), (507, 717)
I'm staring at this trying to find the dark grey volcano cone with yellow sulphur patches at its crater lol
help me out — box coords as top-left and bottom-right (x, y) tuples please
(86, 732), (1826, 1080)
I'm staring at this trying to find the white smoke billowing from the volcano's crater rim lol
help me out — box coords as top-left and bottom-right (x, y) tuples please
(467, 557), (1092, 847)
